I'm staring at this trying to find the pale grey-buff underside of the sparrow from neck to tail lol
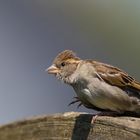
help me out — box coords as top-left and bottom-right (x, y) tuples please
(71, 60), (140, 113)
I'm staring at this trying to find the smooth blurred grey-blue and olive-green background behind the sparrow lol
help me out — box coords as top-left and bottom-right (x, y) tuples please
(0, 0), (140, 124)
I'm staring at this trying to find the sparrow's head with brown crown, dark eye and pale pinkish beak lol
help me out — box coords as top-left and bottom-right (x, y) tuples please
(47, 50), (80, 84)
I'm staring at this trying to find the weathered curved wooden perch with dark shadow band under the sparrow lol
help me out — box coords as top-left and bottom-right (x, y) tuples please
(0, 112), (140, 140)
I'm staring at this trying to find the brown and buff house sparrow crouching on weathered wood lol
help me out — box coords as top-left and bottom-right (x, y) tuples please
(47, 50), (140, 115)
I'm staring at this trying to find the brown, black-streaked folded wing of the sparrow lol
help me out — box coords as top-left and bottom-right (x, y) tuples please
(92, 61), (140, 93)
